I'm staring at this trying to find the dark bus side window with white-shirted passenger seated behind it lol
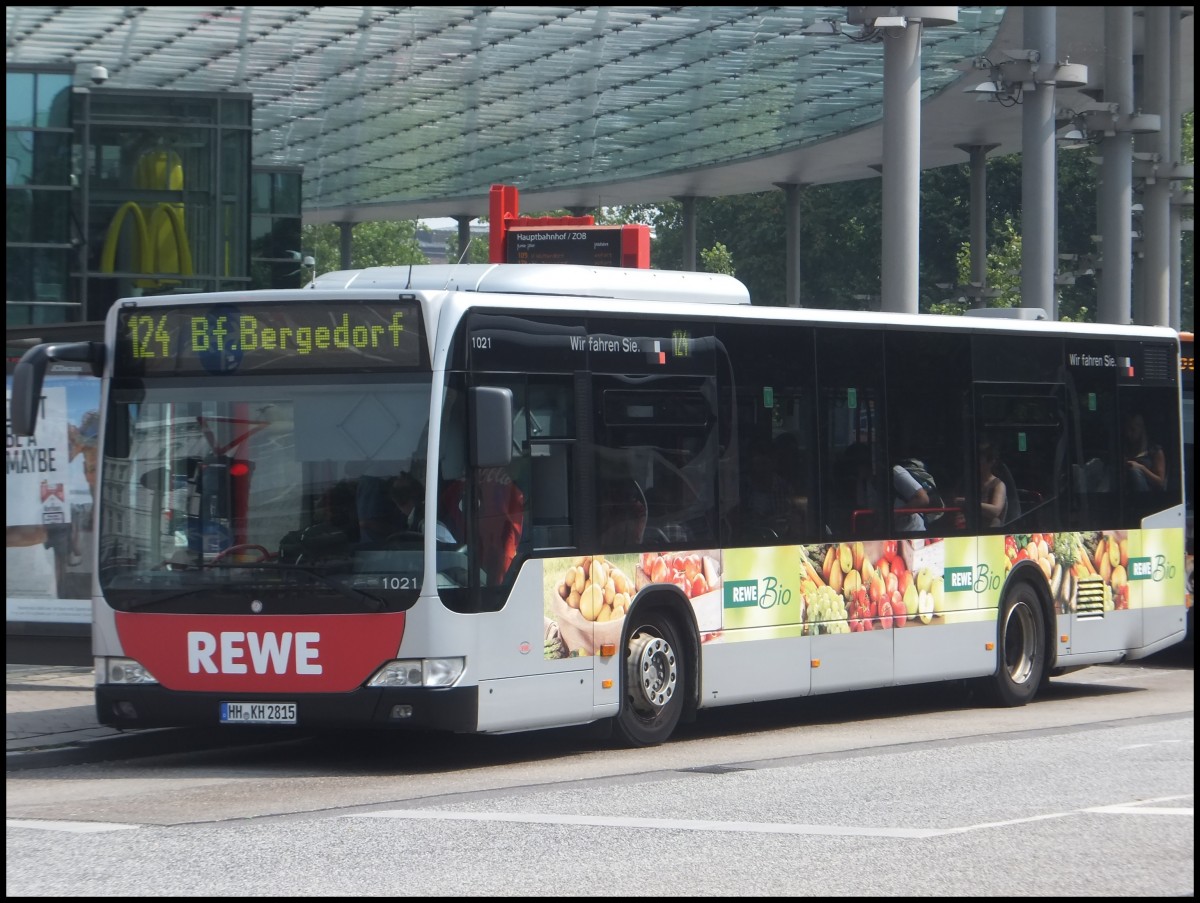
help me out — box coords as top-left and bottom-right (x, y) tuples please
(884, 330), (978, 537)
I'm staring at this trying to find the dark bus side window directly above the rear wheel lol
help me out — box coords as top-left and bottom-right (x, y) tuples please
(976, 383), (1067, 533)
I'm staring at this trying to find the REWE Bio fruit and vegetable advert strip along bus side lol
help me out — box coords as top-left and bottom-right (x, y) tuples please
(545, 530), (1184, 659)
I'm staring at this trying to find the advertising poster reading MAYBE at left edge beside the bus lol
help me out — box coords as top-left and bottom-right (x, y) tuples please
(5, 371), (100, 623)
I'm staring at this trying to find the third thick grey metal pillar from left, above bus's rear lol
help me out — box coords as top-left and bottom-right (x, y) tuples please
(1097, 6), (1133, 324)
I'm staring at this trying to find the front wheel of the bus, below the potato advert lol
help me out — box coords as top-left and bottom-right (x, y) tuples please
(613, 608), (688, 747)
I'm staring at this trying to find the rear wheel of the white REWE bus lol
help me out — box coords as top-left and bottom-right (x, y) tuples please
(986, 580), (1048, 706)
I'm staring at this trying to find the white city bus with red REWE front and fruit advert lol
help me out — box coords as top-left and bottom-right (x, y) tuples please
(12, 264), (1186, 744)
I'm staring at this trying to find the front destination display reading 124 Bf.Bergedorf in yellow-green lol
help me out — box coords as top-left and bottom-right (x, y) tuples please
(115, 299), (430, 376)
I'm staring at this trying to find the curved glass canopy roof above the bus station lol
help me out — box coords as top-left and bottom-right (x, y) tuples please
(5, 6), (1142, 219)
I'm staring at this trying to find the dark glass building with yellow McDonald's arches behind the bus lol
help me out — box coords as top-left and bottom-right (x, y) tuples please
(5, 66), (306, 345)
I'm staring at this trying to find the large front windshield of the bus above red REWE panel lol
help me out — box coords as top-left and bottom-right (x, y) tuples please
(98, 373), (457, 612)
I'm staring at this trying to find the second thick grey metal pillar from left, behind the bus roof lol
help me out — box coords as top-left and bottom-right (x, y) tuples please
(1021, 6), (1058, 319)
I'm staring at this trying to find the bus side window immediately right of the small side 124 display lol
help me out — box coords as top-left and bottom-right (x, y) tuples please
(719, 323), (820, 546)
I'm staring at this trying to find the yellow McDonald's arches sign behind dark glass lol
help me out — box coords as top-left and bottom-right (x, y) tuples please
(100, 150), (193, 288)
